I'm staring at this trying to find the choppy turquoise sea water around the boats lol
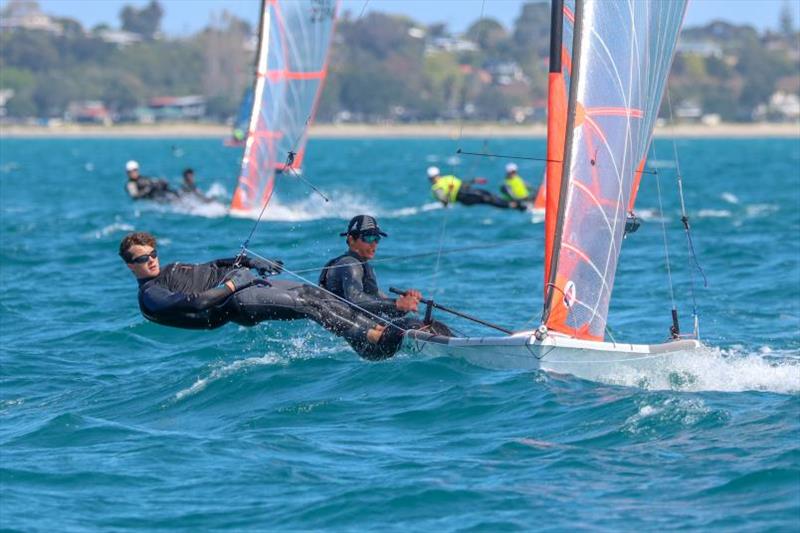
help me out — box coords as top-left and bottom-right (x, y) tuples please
(0, 135), (800, 531)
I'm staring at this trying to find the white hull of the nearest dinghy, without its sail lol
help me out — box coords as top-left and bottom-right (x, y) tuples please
(403, 331), (701, 381)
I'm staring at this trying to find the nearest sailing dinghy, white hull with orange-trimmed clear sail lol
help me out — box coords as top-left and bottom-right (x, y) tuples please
(404, 0), (701, 379)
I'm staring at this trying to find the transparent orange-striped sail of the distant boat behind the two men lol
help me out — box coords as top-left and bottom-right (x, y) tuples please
(231, 0), (338, 211)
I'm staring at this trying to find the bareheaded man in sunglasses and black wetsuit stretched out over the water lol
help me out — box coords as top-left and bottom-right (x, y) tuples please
(120, 232), (399, 354)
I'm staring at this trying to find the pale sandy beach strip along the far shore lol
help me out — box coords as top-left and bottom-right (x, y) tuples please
(0, 123), (800, 137)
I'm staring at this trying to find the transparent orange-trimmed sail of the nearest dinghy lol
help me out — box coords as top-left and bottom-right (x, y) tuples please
(543, 0), (686, 340)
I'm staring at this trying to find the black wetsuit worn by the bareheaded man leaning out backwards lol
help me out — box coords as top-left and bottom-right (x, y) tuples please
(139, 258), (402, 358)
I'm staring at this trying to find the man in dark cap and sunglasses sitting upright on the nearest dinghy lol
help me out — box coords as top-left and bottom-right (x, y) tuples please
(319, 215), (450, 358)
